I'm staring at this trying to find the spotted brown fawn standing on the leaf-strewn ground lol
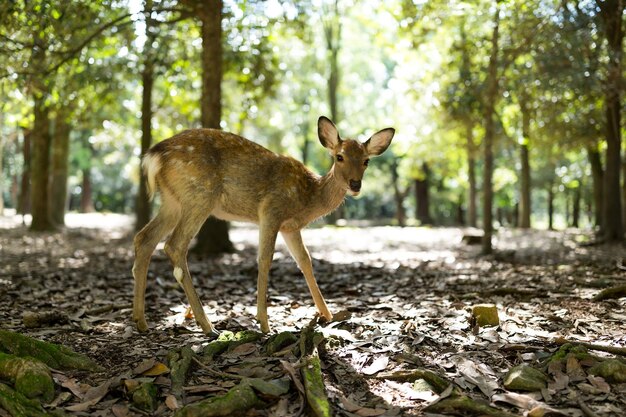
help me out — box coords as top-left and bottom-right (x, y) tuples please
(133, 116), (395, 334)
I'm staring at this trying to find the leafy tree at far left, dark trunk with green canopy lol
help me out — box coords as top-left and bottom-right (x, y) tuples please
(0, 0), (130, 231)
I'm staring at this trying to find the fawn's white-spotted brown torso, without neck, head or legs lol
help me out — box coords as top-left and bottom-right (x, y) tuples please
(150, 129), (316, 222)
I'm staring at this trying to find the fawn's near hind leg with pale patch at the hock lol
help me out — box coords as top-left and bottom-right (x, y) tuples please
(165, 201), (219, 334)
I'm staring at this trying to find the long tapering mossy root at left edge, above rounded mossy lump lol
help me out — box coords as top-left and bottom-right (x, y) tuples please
(0, 330), (101, 371)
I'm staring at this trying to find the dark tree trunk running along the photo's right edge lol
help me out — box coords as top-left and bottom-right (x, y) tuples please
(596, 0), (624, 242)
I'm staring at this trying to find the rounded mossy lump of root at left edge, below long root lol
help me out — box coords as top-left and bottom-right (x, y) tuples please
(0, 352), (54, 402)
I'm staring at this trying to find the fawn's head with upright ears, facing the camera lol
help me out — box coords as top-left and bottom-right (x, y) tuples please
(317, 116), (395, 196)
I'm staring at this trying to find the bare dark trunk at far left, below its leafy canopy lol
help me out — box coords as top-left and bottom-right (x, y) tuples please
(30, 93), (54, 231)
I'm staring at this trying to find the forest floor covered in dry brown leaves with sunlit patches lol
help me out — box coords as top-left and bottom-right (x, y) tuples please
(0, 215), (626, 417)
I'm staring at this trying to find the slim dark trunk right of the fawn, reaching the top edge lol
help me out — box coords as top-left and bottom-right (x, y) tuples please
(482, 3), (500, 254)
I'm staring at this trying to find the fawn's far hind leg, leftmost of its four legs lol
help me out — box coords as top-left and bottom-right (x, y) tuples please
(133, 194), (180, 332)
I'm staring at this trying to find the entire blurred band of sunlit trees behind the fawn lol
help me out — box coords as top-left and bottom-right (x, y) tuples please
(0, 0), (626, 247)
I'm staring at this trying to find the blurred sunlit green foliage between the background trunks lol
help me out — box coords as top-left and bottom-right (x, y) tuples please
(0, 0), (607, 228)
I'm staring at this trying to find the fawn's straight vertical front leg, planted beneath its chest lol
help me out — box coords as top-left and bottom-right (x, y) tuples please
(256, 223), (278, 333)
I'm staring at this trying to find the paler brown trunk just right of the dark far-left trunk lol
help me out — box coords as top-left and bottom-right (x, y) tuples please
(50, 110), (70, 226)
